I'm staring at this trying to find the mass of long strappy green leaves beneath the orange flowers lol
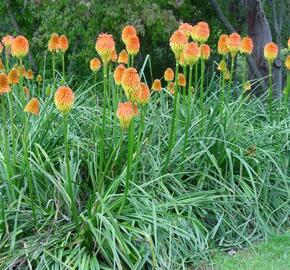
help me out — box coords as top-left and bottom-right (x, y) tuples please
(0, 33), (290, 270)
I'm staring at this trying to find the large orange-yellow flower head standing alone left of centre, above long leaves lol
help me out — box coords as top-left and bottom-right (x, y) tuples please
(54, 86), (74, 114)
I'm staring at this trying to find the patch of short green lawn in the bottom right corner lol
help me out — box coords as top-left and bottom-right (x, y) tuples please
(212, 233), (290, 270)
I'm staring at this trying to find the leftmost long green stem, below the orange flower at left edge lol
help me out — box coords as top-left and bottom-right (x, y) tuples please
(1, 98), (15, 201)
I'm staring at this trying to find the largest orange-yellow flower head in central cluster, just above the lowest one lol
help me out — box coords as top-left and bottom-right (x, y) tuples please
(121, 68), (141, 101)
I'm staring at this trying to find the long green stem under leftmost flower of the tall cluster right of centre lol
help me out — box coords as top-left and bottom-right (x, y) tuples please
(163, 62), (179, 171)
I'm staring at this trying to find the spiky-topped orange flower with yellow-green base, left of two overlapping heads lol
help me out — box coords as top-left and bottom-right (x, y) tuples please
(96, 33), (115, 65)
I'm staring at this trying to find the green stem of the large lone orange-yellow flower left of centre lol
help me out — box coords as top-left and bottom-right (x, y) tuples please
(63, 114), (80, 231)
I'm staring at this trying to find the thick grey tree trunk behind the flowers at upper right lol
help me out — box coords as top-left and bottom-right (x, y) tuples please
(245, 0), (282, 97)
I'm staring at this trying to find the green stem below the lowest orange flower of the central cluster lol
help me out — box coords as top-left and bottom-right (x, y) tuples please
(119, 119), (134, 214)
